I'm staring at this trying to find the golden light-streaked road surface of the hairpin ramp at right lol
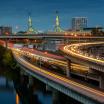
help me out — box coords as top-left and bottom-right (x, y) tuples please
(62, 42), (104, 66)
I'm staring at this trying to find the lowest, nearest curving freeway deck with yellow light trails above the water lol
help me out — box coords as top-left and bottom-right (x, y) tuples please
(12, 49), (104, 104)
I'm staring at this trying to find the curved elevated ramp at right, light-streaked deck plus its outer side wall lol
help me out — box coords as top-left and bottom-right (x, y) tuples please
(61, 42), (104, 72)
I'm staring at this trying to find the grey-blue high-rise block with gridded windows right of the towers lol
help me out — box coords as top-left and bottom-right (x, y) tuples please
(72, 17), (88, 30)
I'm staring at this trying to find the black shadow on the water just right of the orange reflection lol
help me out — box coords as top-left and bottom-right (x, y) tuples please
(13, 71), (41, 104)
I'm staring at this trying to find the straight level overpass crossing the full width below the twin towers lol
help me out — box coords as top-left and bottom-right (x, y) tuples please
(0, 34), (104, 39)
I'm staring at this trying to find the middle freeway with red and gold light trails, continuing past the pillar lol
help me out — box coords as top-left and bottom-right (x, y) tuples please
(15, 48), (89, 71)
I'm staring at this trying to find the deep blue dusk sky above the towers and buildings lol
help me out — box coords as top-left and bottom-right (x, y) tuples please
(0, 0), (104, 31)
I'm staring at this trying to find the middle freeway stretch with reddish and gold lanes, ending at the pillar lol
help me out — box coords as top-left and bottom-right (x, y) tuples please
(17, 48), (67, 67)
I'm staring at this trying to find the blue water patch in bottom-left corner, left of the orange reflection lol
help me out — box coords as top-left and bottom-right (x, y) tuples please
(0, 76), (15, 104)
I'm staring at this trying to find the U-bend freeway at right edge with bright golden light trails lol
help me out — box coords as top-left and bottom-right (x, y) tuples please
(61, 42), (104, 69)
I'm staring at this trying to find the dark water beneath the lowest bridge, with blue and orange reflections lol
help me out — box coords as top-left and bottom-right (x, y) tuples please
(0, 69), (80, 104)
